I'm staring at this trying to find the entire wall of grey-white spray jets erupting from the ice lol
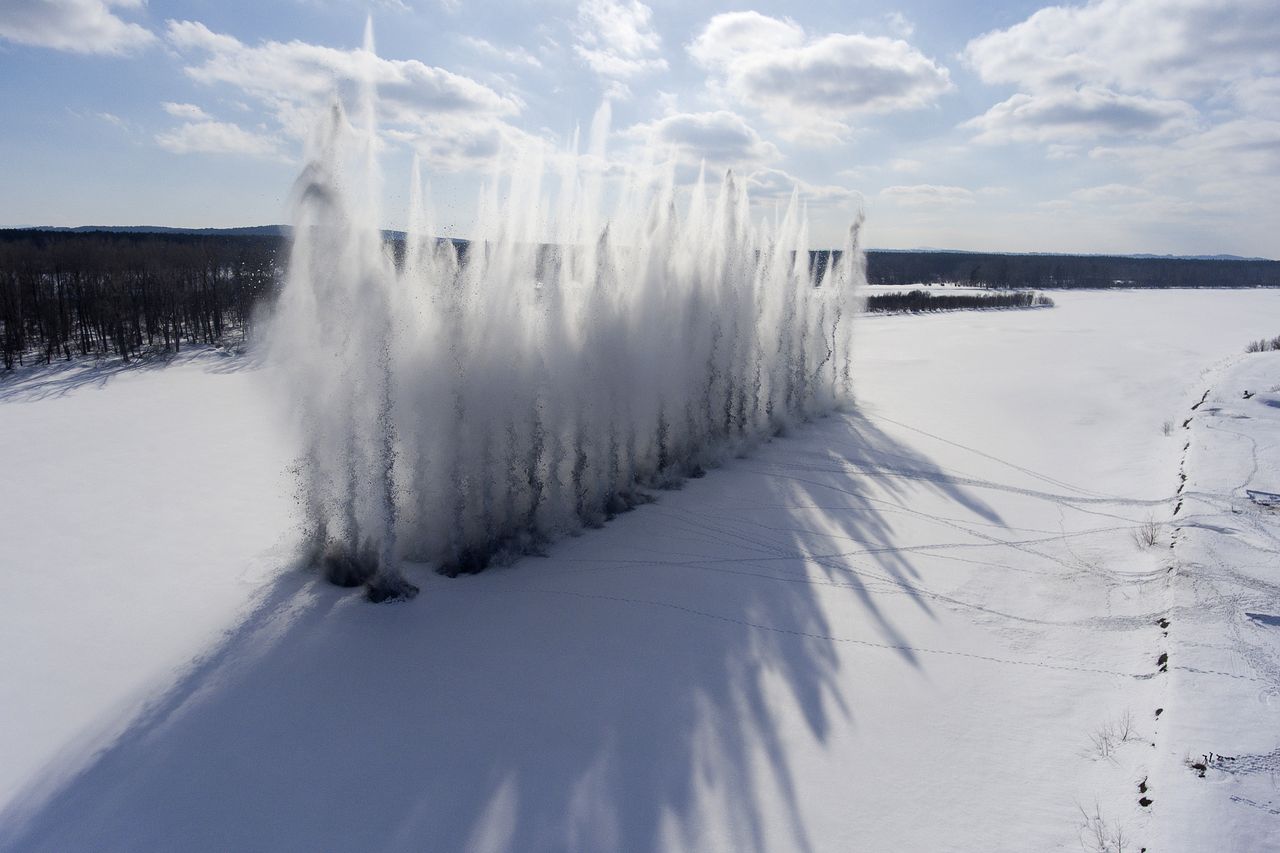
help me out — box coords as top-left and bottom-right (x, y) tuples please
(270, 31), (864, 601)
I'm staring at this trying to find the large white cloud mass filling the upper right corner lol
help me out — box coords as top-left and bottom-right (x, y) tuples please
(963, 0), (1280, 156)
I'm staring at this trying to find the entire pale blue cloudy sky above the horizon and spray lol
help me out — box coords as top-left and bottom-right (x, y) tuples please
(0, 0), (1280, 257)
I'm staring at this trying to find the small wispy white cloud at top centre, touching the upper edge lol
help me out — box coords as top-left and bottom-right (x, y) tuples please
(573, 0), (667, 79)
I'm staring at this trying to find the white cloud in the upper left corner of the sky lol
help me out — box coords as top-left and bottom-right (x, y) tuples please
(0, 0), (156, 54)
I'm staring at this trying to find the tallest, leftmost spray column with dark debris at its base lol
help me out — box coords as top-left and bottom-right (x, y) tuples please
(273, 26), (417, 601)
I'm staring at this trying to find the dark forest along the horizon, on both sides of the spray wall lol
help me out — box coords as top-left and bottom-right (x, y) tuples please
(0, 227), (1280, 369)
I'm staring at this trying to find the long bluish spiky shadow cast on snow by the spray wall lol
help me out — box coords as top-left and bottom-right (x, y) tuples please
(0, 404), (1000, 850)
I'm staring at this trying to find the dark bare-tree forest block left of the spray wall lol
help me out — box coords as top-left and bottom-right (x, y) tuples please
(0, 231), (283, 369)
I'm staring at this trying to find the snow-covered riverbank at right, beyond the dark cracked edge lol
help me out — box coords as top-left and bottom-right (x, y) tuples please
(1152, 352), (1280, 850)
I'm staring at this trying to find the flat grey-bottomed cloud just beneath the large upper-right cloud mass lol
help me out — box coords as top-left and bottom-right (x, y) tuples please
(961, 87), (1197, 143)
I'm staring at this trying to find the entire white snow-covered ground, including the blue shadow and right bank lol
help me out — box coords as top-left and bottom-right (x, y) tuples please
(0, 291), (1280, 853)
